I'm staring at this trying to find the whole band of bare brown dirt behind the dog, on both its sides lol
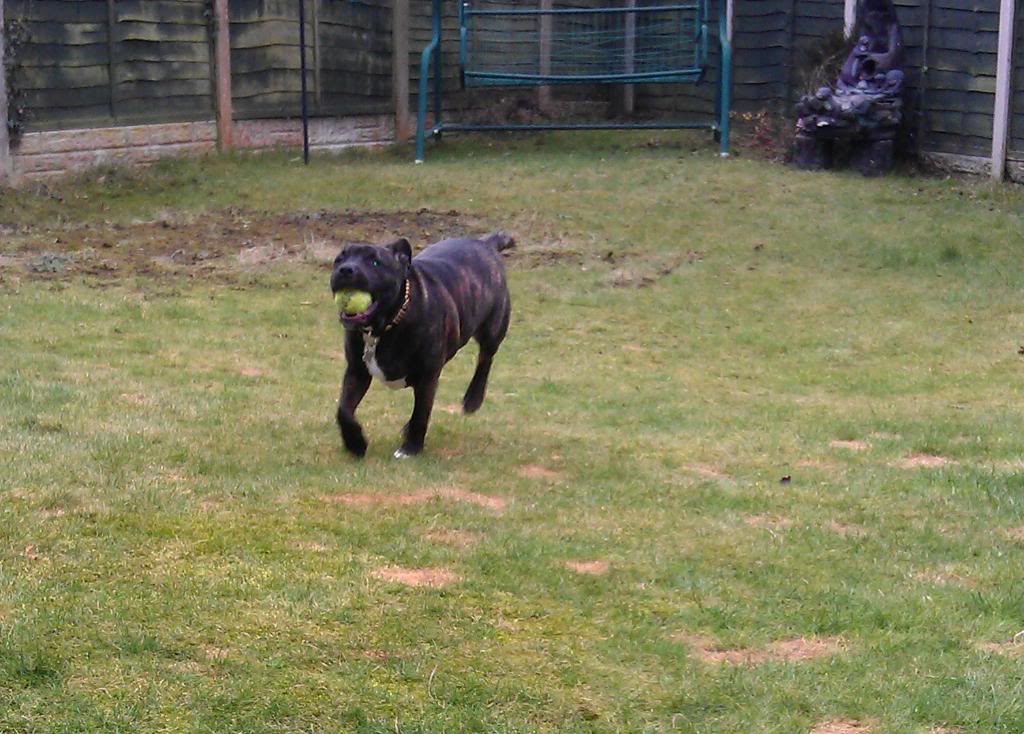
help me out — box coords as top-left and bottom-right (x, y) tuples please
(0, 208), (688, 288)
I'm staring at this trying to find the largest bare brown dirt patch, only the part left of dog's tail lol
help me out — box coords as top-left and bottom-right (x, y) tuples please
(0, 209), (485, 279)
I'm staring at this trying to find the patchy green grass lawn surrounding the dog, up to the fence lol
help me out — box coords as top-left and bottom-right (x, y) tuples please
(0, 135), (1024, 734)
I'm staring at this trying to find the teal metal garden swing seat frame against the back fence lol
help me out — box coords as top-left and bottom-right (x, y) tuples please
(416, 0), (732, 163)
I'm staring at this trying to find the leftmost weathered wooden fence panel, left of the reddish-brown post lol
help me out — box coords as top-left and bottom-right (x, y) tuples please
(6, 0), (212, 130)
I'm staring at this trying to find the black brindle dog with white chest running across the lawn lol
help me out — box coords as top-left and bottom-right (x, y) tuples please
(331, 232), (513, 459)
